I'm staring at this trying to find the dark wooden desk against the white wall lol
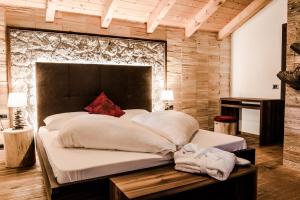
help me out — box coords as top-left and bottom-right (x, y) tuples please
(221, 97), (284, 145)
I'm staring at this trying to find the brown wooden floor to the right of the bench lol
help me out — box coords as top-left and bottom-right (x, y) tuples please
(241, 134), (300, 200)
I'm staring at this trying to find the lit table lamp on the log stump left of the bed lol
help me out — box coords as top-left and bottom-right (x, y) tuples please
(7, 92), (27, 130)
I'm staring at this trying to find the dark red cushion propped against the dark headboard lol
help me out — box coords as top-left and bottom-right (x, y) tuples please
(84, 92), (125, 117)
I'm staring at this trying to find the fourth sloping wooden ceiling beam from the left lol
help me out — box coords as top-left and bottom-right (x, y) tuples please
(185, 0), (226, 37)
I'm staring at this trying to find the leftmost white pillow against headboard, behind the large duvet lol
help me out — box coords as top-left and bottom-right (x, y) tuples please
(44, 112), (89, 131)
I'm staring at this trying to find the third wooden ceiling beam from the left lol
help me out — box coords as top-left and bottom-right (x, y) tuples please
(147, 0), (176, 33)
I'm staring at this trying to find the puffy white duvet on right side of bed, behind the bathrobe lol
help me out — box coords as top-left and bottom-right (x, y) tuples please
(132, 111), (199, 146)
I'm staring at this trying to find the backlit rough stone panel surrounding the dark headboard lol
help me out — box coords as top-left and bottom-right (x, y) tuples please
(8, 29), (166, 125)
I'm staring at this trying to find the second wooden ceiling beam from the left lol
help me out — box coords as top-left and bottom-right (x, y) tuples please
(101, 0), (119, 28)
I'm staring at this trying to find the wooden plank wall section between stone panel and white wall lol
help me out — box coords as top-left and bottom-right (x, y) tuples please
(166, 28), (230, 129)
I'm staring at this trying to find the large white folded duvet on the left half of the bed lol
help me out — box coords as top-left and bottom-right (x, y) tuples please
(57, 115), (176, 154)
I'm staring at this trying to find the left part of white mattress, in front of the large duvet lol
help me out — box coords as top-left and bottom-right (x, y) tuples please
(38, 127), (173, 184)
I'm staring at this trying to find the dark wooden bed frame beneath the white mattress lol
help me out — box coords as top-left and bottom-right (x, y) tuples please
(36, 134), (255, 200)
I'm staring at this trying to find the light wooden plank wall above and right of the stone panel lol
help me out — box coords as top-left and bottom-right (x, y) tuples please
(1, 8), (231, 129)
